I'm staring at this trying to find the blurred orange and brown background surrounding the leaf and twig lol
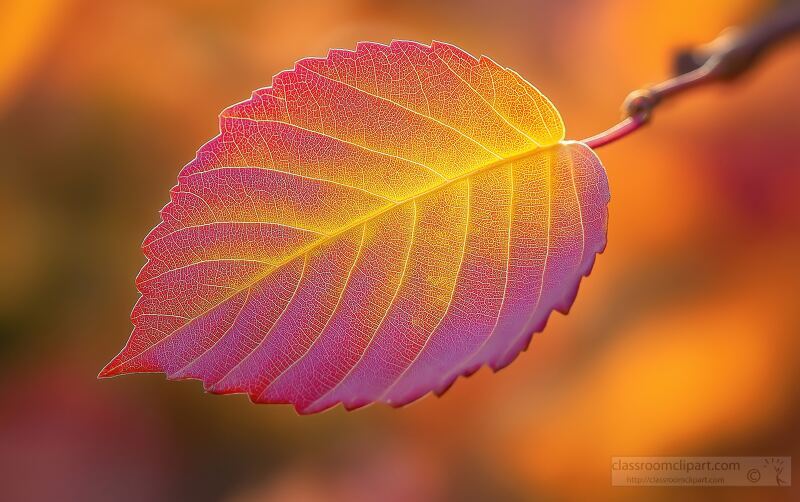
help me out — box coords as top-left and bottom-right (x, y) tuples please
(0, 0), (800, 501)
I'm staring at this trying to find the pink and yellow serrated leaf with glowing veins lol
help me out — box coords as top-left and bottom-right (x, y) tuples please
(101, 41), (608, 413)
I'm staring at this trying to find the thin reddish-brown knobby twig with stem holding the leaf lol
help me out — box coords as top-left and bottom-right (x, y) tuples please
(583, 2), (800, 148)
